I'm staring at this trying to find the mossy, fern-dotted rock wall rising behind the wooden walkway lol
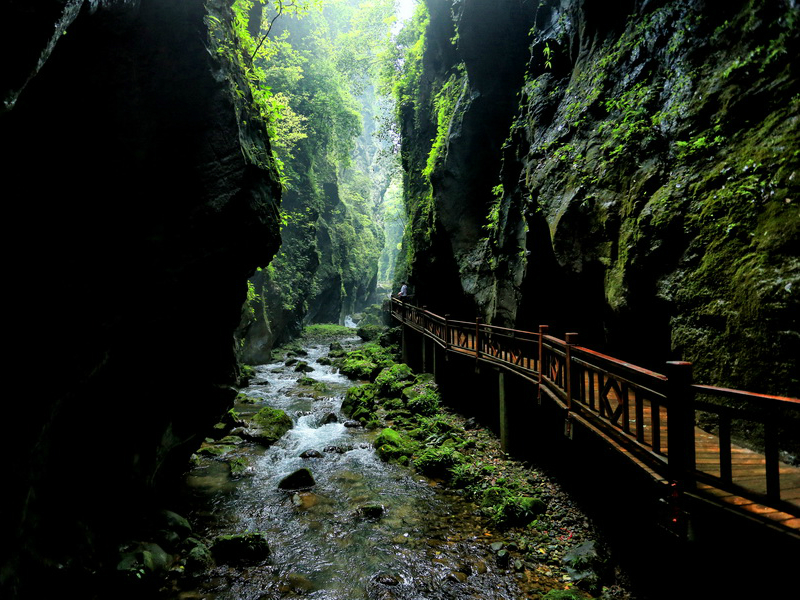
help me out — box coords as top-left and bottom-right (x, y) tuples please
(400, 0), (800, 396)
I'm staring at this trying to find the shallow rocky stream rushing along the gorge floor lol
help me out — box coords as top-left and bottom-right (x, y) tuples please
(177, 338), (524, 600)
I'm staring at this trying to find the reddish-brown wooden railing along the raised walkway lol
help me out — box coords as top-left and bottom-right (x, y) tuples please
(392, 299), (800, 516)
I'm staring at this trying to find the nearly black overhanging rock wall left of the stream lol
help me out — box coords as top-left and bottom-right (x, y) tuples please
(0, 0), (279, 597)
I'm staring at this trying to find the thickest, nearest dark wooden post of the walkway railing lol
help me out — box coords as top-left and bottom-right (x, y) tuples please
(666, 361), (695, 489)
